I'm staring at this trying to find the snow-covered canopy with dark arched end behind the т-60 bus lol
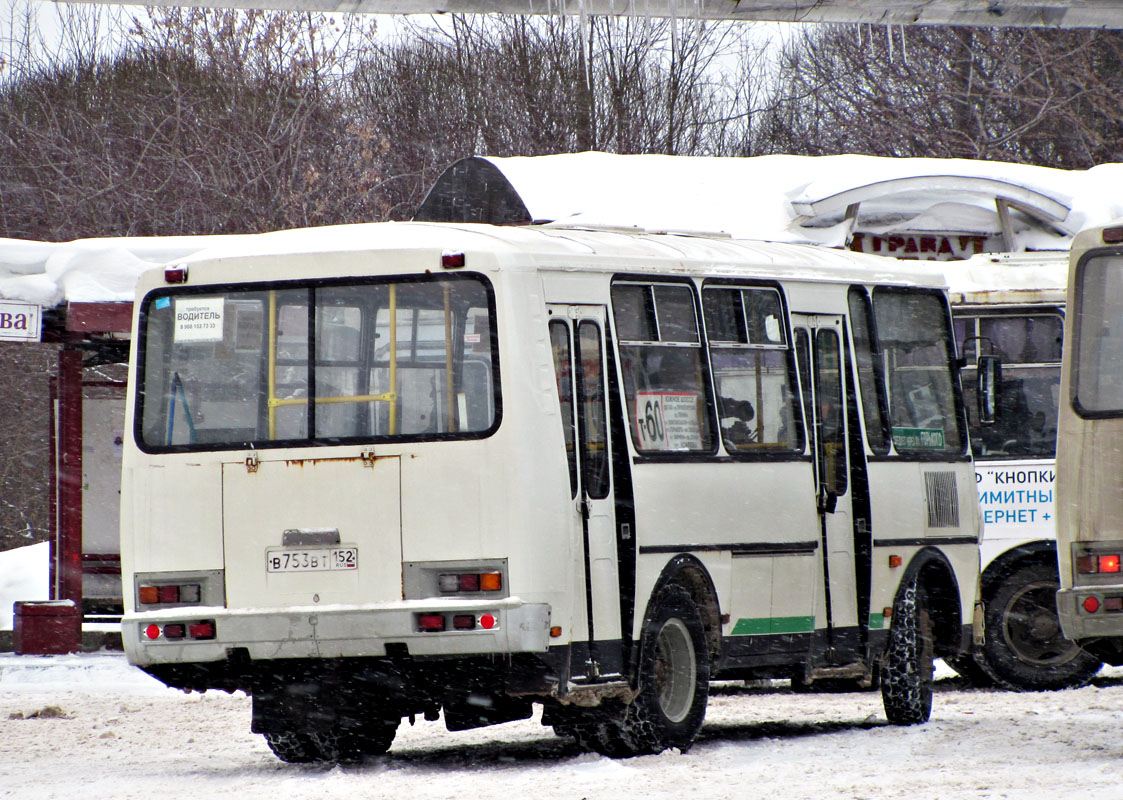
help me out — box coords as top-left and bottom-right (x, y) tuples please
(414, 153), (1123, 257)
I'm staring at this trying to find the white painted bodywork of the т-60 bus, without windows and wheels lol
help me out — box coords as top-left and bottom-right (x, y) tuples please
(122, 225), (978, 678)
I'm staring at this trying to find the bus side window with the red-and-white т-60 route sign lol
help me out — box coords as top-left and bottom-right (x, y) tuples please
(612, 282), (714, 453)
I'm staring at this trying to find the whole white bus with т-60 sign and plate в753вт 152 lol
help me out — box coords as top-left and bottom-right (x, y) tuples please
(121, 222), (980, 762)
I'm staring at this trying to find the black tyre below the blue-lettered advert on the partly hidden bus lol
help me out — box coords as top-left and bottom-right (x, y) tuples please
(978, 563), (1102, 691)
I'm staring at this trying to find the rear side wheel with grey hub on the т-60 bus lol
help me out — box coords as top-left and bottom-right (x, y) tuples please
(573, 584), (710, 758)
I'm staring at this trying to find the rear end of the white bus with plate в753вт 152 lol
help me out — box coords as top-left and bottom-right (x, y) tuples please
(122, 242), (572, 761)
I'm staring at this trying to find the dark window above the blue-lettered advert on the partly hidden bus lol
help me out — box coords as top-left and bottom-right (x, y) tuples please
(956, 312), (1063, 458)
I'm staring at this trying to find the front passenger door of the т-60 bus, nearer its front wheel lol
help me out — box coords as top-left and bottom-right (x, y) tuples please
(793, 315), (865, 666)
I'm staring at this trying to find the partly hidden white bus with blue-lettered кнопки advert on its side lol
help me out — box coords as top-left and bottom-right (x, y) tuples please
(944, 253), (1101, 690)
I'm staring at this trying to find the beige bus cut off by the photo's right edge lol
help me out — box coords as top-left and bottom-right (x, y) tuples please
(1057, 220), (1123, 665)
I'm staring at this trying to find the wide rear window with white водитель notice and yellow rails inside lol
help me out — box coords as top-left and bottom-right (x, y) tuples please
(137, 275), (499, 451)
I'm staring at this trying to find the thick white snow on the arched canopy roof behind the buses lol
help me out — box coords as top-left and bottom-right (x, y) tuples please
(486, 153), (1123, 249)
